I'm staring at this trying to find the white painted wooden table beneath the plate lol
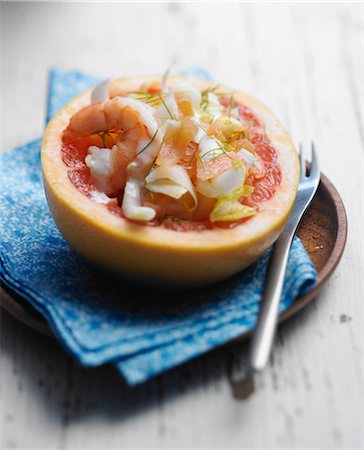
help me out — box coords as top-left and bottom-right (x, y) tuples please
(0, 3), (364, 450)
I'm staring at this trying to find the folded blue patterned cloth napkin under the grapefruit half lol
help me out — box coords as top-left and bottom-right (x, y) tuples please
(0, 70), (317, 385)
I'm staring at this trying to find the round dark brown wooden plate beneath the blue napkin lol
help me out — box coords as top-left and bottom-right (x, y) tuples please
(0, 174), (347, 339)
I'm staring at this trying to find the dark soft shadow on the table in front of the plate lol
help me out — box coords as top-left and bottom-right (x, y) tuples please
(1, 303), (314, 432)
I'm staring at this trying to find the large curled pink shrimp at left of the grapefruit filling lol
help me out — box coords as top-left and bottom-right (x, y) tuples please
(66, 85), (161, 221)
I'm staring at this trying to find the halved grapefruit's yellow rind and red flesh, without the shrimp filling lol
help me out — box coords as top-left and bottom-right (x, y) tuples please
(42, 76), (299, 286)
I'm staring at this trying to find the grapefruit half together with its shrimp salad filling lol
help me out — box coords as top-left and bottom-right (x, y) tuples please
(42, 76), (299, 286)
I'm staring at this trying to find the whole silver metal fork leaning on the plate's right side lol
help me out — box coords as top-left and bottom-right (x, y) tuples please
(249, 142), (320, 371)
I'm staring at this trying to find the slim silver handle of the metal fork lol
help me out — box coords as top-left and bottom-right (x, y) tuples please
(249, 232), (293, 371)
